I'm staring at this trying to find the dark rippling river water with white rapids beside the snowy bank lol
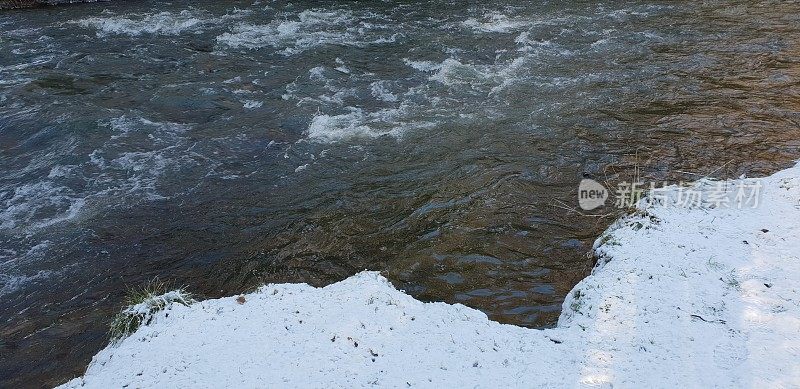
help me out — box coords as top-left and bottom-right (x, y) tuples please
(0, 0), (800, 387)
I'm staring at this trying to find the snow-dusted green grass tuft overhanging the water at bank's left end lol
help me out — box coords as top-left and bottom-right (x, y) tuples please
(109, 279), (195, 343)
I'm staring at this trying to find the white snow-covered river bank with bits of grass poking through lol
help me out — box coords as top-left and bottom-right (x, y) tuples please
(61, 166), (800, 388)
